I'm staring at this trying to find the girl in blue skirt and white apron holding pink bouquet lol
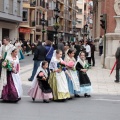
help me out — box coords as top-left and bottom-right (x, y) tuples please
(65, 49), (80, 97)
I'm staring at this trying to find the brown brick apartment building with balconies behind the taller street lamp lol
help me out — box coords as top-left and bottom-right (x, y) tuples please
(48, 0), (76, 41)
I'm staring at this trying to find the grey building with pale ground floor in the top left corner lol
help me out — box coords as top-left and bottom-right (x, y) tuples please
(0, 0), (22, 42)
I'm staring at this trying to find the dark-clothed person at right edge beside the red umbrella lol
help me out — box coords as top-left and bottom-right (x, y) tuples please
(115, 43), (120, 83)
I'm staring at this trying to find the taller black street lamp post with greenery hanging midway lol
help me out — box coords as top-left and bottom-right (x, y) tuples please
(54, 0), (60, 49)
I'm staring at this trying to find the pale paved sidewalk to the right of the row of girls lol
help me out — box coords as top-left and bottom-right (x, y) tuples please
(88, 53), (120, 95)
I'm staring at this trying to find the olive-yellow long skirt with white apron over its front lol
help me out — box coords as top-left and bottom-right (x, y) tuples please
(49, 72), (70, 100)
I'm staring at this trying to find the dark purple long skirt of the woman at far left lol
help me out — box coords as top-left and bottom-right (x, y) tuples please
(1, 72), (19, 101)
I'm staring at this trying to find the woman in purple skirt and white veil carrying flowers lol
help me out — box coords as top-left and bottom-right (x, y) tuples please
(1, 47), (22, 102)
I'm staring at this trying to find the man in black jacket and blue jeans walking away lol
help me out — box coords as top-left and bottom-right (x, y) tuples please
(28, 42), (46, 81)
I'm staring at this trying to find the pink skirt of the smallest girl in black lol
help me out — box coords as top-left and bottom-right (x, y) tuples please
(28, 81), (53, 100)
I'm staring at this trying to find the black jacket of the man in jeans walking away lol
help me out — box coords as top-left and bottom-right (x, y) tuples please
(33, 45), (46, 61)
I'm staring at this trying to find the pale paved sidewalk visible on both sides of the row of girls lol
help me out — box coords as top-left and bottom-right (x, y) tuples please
(21, 53), (120, 95)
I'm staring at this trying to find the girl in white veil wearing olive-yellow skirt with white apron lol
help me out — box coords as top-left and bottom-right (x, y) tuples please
(49, 50), (70, 101)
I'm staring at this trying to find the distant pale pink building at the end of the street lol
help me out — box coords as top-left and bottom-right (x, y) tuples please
(76, 0), (93, 39)
